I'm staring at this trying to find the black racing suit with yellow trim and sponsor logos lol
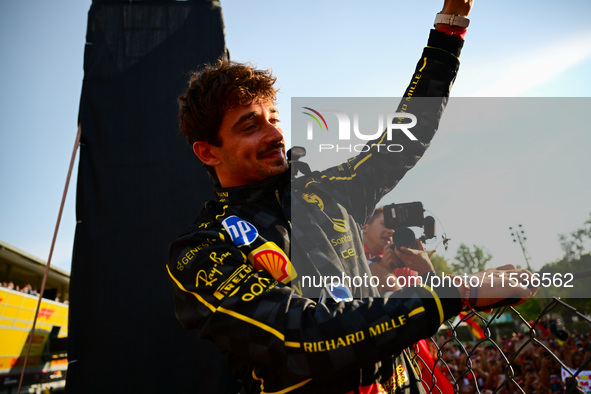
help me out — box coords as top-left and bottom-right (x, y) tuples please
(167, 31), (463, 394)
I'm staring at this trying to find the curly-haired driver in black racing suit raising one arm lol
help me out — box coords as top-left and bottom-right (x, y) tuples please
(167, 0), (532, 394)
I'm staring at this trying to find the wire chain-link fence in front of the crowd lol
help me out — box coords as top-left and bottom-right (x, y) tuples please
(413, 297), (591, 394)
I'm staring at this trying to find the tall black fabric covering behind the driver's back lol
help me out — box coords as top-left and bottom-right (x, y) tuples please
(67, 1), (239, 394)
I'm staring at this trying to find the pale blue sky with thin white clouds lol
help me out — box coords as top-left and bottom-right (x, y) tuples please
(0, 0), (591, 271)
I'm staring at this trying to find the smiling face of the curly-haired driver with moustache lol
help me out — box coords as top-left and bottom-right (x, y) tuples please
(201, 100), (287, 187)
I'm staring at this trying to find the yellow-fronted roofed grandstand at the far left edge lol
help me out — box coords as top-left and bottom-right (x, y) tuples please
(0, 241), (69, 393)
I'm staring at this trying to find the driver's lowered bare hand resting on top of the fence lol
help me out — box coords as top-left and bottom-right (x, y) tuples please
(459, 264), (538, 310)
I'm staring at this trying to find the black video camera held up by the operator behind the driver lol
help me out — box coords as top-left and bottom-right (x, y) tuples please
(384, 201), (435, 248)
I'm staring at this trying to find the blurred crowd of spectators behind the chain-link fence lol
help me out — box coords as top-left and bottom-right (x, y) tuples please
(435, 318), (591, 394)
